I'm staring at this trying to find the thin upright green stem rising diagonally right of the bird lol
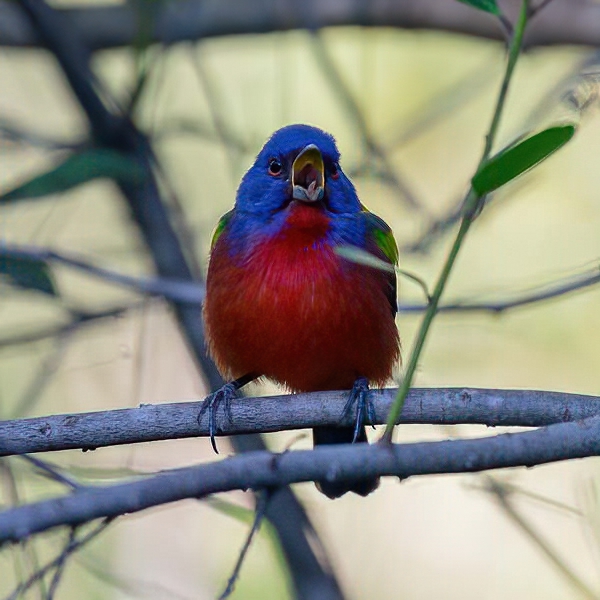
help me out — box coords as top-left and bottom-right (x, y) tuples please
(381, 0), (529, 443)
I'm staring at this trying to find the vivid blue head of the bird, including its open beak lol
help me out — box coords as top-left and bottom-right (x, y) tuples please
(236, 125), (361, 219)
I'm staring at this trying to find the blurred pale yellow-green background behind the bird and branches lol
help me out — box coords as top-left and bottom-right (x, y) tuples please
(0, 0), (600, 600)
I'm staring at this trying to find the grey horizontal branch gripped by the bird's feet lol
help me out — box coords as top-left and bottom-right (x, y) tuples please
(0, 388), (600, 456)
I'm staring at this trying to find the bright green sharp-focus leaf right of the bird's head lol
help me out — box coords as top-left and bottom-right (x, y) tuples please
(471, 124), (575, 196)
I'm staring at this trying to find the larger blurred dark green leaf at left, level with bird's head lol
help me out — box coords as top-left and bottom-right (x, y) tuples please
(0, 148), (144, 204)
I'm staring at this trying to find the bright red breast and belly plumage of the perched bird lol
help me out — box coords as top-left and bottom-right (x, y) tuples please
(204, 207), (399, 391)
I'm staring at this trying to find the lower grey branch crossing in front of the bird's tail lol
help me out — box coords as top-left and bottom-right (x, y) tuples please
(0, 416), (600, 542)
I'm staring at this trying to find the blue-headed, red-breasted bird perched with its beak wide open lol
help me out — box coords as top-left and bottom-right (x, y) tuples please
(203, 124), (400, 498)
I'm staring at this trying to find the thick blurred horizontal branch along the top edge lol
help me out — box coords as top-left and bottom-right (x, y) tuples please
(0, 0), (600, 50)
